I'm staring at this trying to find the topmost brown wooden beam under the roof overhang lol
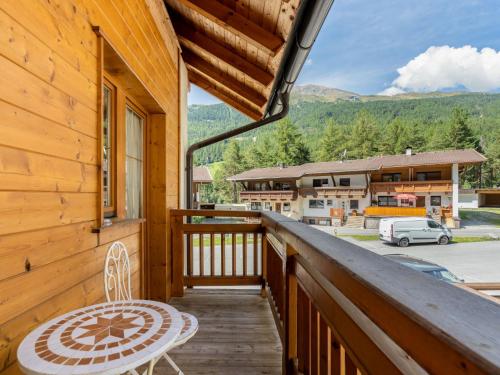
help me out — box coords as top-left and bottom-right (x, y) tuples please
(172, 0), (284, 56)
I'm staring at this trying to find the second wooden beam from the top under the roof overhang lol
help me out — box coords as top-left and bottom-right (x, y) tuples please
(173, 17), (274, 87)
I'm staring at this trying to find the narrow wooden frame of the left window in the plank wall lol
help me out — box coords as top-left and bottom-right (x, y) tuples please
(100, 77), (118, 218)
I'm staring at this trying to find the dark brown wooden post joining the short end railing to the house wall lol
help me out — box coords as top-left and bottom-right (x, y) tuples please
(171, 216), (184, 297)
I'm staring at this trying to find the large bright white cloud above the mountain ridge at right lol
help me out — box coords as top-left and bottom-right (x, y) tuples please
(380, 46), (500, 95)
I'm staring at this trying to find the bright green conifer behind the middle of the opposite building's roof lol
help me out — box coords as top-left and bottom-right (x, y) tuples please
(349, 110), (378, 159)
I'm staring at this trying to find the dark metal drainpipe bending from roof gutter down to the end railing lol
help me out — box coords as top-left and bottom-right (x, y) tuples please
(186, 93), (289, 209)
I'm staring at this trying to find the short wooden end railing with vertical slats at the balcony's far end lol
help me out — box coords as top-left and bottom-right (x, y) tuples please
(171, 210), (263, 295)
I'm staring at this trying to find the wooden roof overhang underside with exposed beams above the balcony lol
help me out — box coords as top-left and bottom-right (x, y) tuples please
(165, 0), (301, 119)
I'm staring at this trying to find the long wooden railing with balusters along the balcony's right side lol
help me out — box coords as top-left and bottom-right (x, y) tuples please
(172, 211), (500, 374)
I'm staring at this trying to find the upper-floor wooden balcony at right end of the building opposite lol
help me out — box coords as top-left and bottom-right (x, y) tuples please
(370, 180), (452, 193)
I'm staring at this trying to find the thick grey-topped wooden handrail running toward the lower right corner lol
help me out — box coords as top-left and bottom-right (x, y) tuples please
(262, 212), (500, 374)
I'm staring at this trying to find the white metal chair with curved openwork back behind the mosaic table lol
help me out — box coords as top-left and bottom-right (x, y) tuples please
(104, 241), (198, 375)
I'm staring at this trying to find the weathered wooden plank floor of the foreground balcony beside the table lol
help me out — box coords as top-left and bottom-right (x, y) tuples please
(151, 289), (282, 375)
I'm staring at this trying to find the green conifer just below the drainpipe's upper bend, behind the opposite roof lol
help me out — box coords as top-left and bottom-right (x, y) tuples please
(274, 118), (311, 165)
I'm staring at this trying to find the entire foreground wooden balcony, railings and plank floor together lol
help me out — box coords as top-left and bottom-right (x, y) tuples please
(171, 210), (500, 375)
